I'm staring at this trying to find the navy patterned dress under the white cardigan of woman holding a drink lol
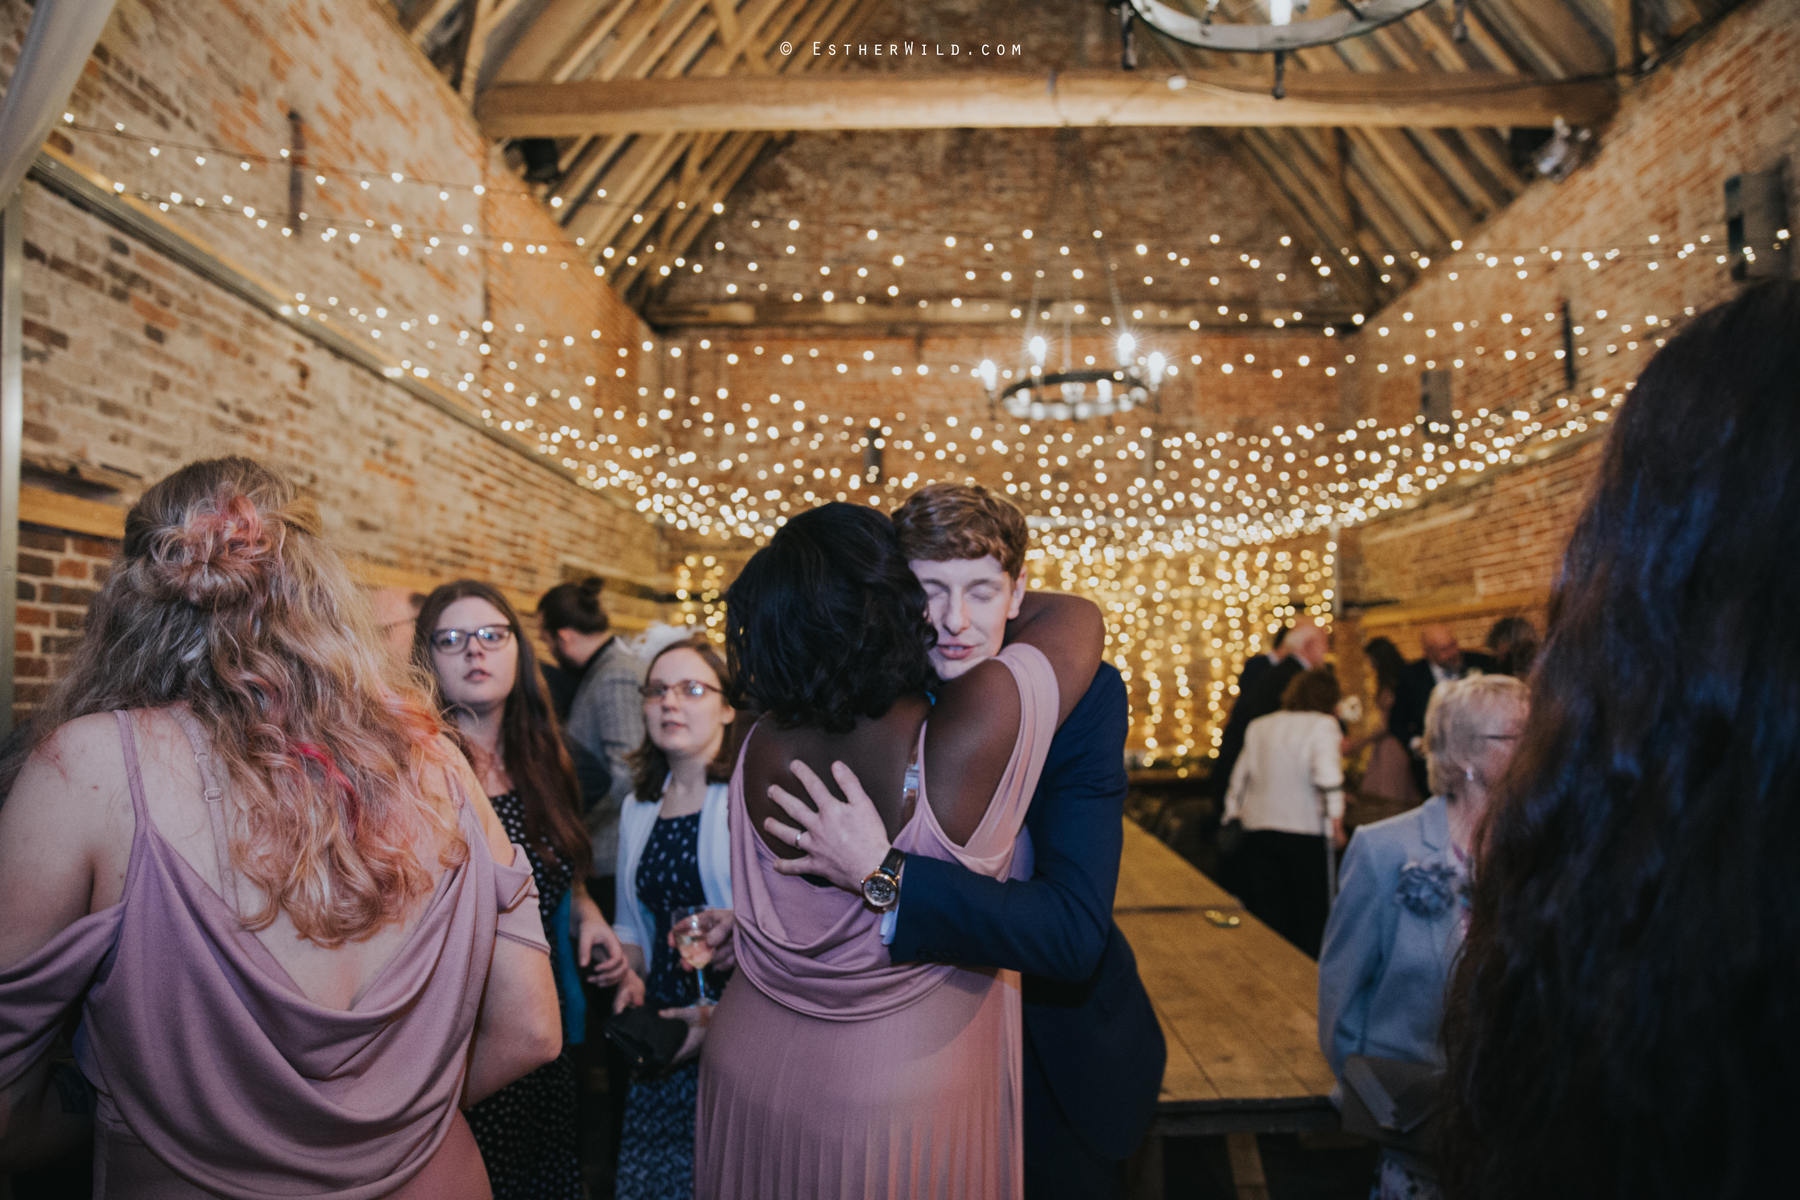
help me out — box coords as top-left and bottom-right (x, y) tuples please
(616, 813), (718, 1200)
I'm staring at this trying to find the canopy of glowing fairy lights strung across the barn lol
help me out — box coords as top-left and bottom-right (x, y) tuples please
(49, 119), (1787, 761)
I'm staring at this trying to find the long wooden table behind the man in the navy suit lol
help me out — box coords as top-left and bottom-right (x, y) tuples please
(1112, 820), (1337, 1200)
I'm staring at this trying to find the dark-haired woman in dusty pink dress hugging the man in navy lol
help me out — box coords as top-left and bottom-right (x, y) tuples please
(695, 504), (1103, 1200)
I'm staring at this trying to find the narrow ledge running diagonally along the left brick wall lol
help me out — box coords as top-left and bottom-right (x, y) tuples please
(29, 149), (639, 515)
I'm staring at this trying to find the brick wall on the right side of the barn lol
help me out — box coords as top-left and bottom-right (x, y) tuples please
(1337, 0), (1800, 672)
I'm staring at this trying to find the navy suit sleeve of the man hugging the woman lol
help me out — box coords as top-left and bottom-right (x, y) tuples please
(889, 666), (1127, 982)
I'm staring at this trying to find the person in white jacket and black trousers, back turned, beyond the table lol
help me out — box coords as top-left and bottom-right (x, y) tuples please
(1224, 667), (1345, 959)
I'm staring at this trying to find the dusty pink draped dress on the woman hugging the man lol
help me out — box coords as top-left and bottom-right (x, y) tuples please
(695, 646), (1057, 1200)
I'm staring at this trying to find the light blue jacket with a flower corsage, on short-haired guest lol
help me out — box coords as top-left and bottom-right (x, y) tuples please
(1319, 795), (1465, 1094)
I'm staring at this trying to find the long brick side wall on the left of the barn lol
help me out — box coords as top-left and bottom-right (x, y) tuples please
(0, 0), (666, 723)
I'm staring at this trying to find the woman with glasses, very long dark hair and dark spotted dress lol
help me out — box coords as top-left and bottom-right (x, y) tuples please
(414, 579), (628, 1200)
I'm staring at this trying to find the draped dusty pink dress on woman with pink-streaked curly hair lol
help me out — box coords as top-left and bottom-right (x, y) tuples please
(0, 712), (549, 1200)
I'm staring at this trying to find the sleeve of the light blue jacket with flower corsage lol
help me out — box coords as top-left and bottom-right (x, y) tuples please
(1319, 829), (1399, 1081)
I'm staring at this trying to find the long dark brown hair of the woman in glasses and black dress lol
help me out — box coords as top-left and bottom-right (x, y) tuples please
(412, 579), (594, 873)
